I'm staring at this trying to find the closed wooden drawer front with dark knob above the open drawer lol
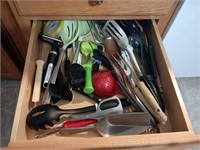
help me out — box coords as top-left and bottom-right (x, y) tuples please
(14, 0), (177, 20)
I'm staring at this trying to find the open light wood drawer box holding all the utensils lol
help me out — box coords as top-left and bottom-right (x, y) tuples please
(9, 20), (200, 149)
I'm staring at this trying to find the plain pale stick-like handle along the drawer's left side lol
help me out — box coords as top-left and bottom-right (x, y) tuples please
(32, 60), (45, 103)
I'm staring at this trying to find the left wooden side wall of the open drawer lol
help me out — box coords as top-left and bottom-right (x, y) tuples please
(10, 22), (41, 142)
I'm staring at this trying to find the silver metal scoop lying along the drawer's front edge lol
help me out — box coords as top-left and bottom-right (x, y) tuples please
(59, 112), (155, 137)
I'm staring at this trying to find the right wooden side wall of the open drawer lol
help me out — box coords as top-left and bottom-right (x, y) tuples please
(148, 21), (193, 132)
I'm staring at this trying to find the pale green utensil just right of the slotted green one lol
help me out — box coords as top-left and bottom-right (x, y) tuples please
(72, 21), (91, 64)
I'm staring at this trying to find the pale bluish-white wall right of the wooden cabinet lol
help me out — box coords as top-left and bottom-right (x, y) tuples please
(164, 0), (200, 77)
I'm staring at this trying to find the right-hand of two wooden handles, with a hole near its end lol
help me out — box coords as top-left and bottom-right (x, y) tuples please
(137, 81), (167, 124)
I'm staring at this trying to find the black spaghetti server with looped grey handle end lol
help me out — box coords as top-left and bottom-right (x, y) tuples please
(26, 97), (123, 130)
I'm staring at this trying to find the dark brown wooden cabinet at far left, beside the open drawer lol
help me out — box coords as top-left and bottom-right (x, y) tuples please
(1, 1), (31, 79)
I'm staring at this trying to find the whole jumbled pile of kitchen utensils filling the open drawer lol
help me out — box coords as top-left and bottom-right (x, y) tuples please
(26, 20), (167, 138)
